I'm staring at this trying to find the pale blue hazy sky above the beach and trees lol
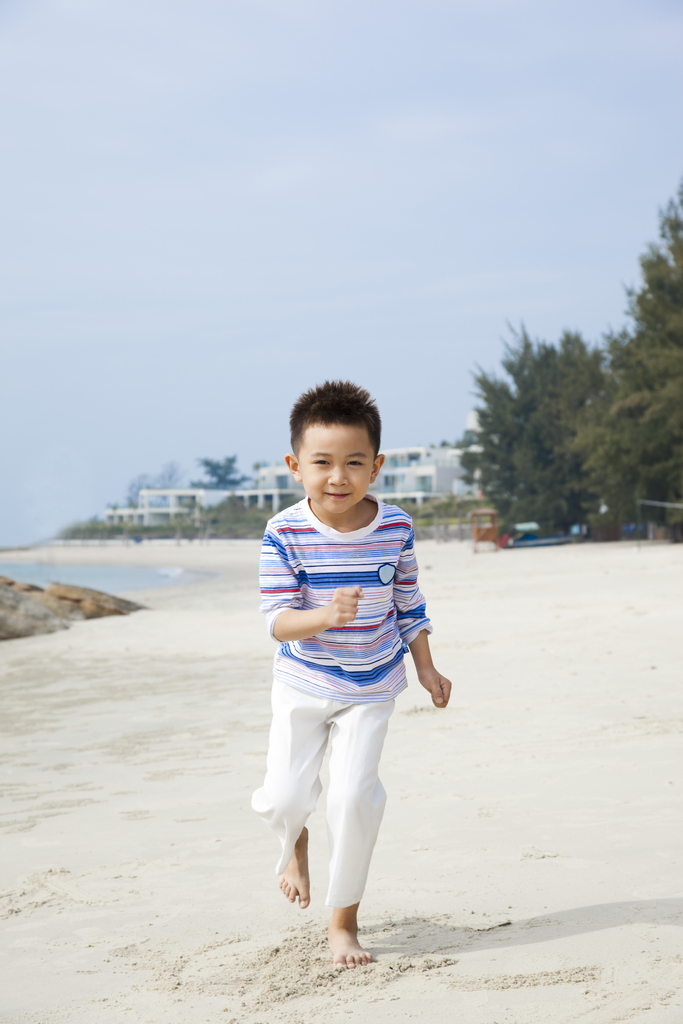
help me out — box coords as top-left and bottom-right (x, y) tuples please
(0, 0), (683, 546)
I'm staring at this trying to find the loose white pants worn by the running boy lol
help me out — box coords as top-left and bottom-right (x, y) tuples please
(252, 681), (394, 907)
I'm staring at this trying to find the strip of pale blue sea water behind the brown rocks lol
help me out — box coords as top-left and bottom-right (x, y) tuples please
(0, 562), (218, 594)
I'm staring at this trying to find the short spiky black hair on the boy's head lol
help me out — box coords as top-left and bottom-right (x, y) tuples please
(290, 381), (382, 455)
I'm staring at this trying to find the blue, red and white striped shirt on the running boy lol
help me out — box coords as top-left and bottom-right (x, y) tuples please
(260, 498), (432, 703)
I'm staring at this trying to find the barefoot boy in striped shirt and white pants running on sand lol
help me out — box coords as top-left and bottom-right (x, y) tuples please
(252, 381), (451, 969)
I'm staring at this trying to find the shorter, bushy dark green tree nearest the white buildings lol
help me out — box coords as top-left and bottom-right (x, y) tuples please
(461, 330), (607, 529)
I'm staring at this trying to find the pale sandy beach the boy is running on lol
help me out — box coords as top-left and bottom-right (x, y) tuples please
(0, 542), (683, 1024)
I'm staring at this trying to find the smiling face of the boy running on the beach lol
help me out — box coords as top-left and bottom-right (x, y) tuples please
(285, 423), (384, 514)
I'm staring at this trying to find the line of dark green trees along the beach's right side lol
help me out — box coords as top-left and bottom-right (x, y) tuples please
(459, 181), (683, 534)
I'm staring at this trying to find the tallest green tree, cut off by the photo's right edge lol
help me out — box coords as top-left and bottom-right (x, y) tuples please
(580, 181), (683, 521)
